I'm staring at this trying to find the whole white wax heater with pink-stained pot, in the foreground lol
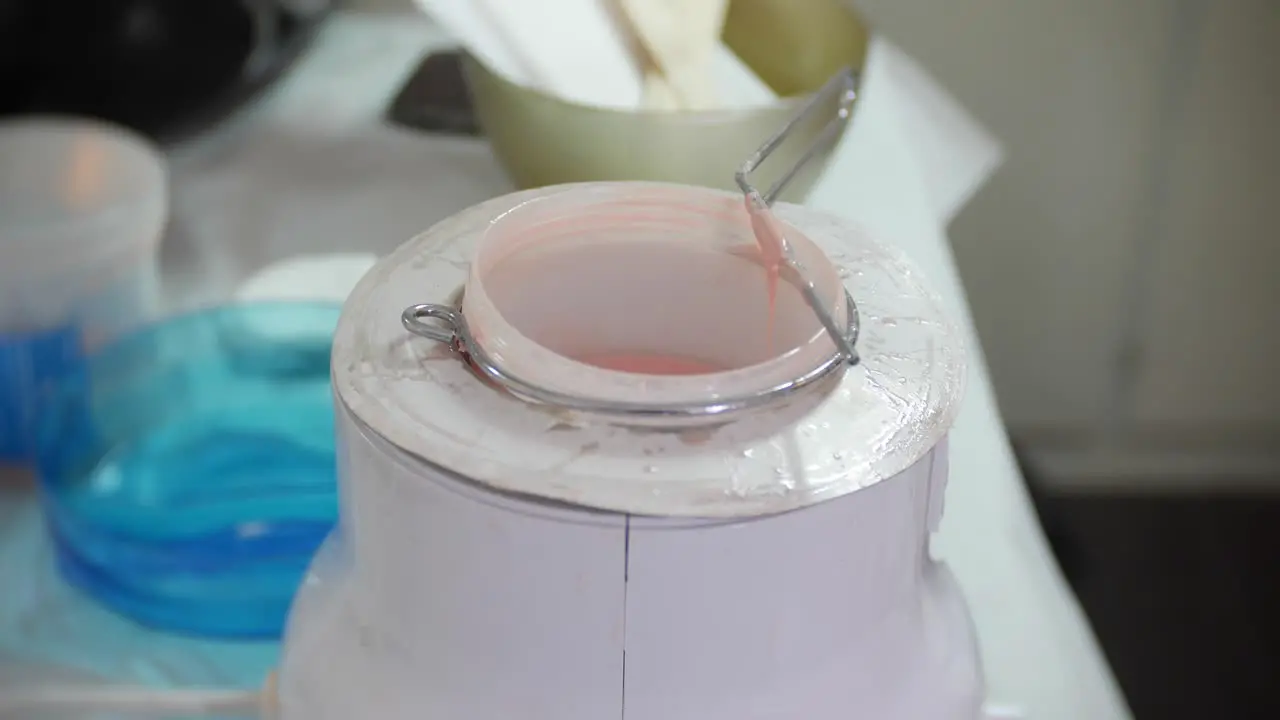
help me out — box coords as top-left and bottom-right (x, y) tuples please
(279, 176), (983, 720)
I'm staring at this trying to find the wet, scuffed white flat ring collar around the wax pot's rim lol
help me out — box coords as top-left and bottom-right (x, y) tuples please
(333, 183), (965, 518)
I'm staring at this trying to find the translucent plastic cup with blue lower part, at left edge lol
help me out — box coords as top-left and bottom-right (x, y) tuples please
(0, 117), (169, 464)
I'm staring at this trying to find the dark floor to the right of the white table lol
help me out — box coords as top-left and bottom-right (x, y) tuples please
(1043, 489), (1280, 720)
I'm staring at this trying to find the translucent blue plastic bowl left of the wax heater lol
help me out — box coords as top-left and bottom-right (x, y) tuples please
(36, 302), (340, 638)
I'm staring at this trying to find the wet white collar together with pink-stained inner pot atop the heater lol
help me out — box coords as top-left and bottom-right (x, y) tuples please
(334, 183), (964, 516)
